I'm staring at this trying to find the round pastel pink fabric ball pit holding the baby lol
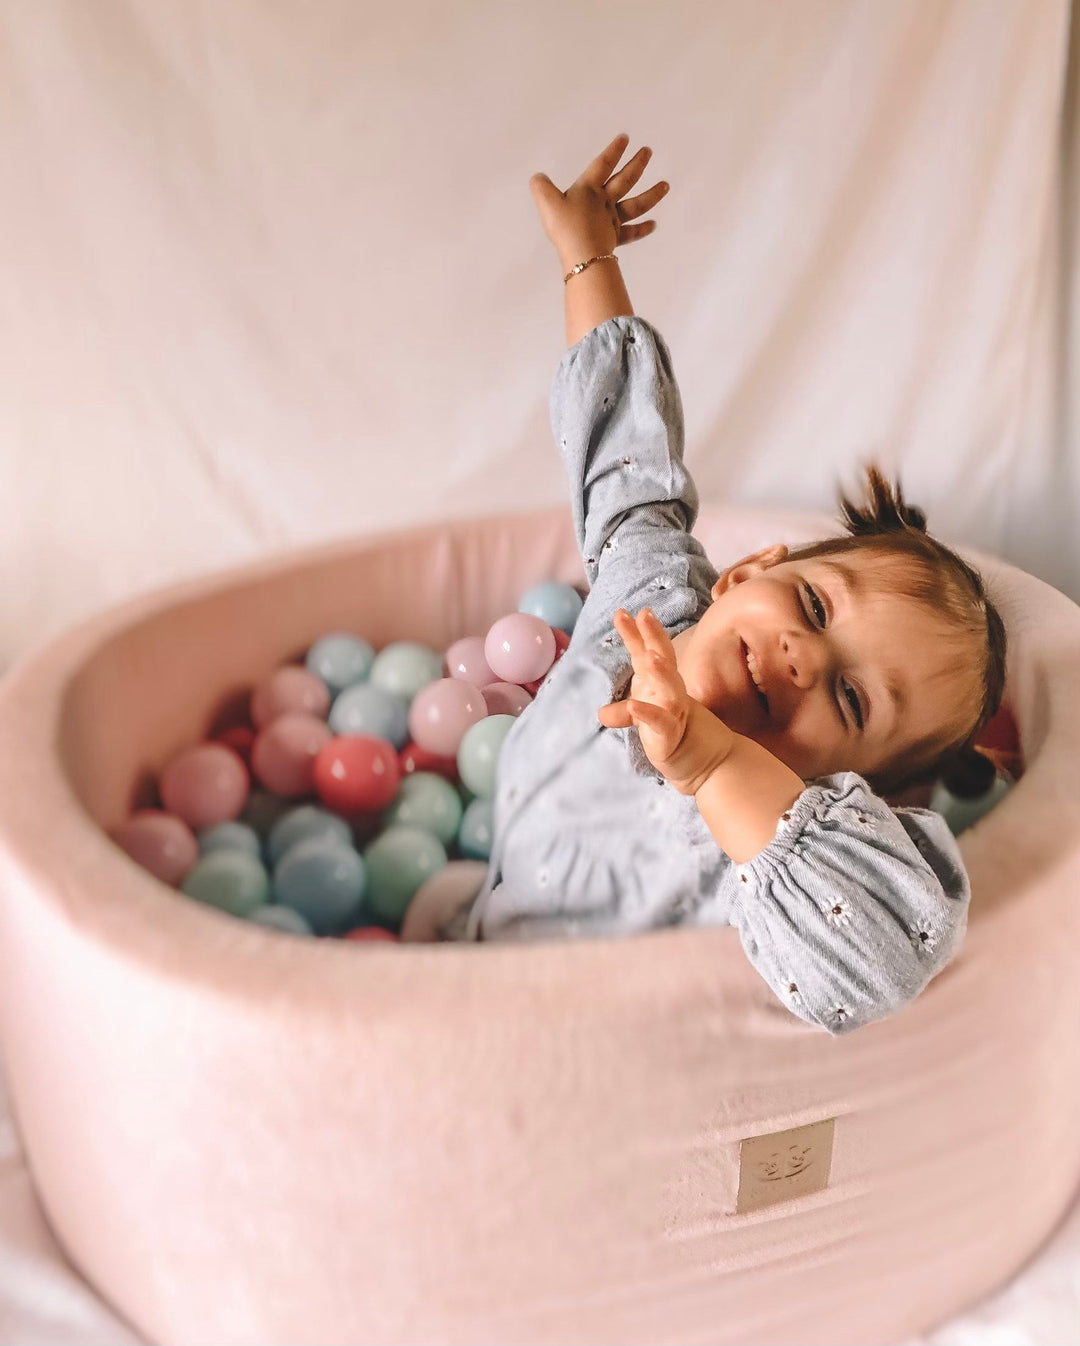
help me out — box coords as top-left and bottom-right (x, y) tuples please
(0, 509), (1080, 1346)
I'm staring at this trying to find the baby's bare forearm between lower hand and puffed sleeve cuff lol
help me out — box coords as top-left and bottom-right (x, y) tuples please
(694, 734), (805, 864)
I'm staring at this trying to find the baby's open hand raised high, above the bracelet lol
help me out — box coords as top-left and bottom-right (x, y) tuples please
(529, 135), (668, 269)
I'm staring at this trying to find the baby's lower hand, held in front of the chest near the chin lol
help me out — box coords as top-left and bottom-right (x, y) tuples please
(597, 607), (734, 794)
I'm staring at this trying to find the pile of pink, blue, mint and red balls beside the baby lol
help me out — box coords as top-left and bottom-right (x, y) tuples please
(110, 581), (582, 940)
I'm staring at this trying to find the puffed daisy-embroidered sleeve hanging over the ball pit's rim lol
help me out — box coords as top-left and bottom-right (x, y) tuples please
(731, 771), (971, 1034)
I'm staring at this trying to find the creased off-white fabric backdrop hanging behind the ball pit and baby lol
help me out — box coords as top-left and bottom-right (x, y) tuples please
(0, 0), (1080, 1346)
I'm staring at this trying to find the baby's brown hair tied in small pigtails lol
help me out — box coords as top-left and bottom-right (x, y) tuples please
(786, 463), (1006, 794)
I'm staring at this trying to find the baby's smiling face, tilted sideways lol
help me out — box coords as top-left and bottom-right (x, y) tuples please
(672, 546), (959, 781)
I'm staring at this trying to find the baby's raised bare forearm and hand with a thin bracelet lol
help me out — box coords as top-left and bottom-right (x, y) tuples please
(529, 136), (668, 346)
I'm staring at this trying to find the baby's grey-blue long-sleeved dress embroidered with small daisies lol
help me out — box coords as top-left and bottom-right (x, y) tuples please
(459, 318), (970, 1034)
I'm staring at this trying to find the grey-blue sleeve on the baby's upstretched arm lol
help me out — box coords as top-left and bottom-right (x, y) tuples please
(551, 316), (699, 584)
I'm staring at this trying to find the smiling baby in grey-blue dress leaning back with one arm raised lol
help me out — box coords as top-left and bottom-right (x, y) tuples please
(444, 136), (1005, 1034)
